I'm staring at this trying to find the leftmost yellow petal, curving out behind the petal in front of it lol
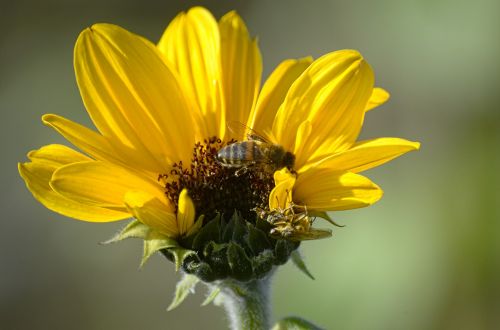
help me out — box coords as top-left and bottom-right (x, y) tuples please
(19, 144), (130, 222)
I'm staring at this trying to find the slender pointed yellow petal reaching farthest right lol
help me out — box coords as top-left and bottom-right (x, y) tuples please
(308, 138), (420, 172)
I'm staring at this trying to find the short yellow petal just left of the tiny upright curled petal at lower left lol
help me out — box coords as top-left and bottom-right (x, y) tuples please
(124, 191), (179, 237)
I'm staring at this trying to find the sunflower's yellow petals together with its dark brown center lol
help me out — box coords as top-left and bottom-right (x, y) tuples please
(19, 7), (419, 278)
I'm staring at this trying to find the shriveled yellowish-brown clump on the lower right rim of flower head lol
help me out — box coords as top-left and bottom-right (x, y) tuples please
(255, 203), (332, 241)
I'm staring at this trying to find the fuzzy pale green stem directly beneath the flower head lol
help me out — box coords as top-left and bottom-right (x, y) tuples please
(213, 275), (271, 330)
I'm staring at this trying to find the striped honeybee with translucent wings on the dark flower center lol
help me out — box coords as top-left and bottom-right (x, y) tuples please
(217, 122), (295, 172)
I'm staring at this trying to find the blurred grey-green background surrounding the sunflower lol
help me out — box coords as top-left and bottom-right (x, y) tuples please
(0, 0), (500, 330)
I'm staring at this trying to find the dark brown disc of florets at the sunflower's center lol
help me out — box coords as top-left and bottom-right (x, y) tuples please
(158, 137), (274, 221)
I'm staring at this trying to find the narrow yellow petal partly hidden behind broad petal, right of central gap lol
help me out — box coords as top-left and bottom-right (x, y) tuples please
(247, 57), (312, 142)
